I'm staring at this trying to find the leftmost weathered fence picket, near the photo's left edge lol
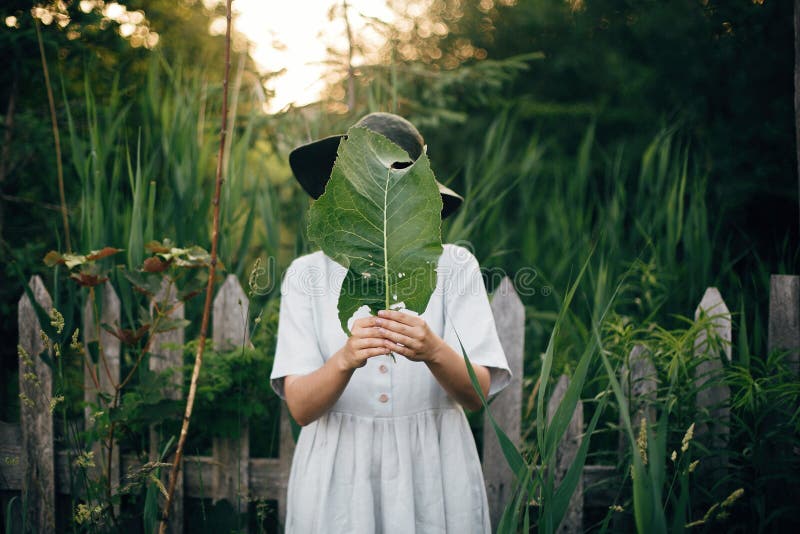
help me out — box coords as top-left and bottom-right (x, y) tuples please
(17, 275), (55, 532)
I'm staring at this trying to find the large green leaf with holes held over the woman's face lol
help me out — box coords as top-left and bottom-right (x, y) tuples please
(308, 128), (442, 332)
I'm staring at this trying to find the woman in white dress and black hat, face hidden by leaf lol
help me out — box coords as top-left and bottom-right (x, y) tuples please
(271, 113), (510, 534)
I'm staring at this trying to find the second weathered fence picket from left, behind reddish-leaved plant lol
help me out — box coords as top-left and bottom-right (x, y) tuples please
(83, 282), (120, 506)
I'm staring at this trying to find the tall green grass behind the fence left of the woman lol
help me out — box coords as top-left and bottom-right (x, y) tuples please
(64, 57), (279, 280)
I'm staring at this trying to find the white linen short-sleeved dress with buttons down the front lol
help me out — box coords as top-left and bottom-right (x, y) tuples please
(271, 245), (511, 534)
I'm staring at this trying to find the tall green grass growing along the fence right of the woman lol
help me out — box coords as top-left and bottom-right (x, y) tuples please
(422, 109), (791, 532)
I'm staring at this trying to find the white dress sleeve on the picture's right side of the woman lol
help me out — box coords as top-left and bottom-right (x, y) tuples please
(444, 246), (511, 395)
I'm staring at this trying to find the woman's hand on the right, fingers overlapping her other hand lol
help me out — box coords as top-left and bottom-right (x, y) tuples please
(375, 310), (445, 363)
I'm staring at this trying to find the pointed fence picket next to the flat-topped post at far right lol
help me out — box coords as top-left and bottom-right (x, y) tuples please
(694, 287), (732, 470)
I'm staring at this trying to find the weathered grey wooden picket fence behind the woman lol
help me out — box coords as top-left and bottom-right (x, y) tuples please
(0, 275), (800, 533)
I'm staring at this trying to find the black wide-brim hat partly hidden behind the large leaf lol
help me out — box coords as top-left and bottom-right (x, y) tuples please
(289, 113), (464, 219)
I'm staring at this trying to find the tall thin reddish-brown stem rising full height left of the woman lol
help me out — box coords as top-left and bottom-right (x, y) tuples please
(159, 0), (233, 534)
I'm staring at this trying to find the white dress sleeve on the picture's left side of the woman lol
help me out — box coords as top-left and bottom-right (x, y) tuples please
(270, 260), (325, 399)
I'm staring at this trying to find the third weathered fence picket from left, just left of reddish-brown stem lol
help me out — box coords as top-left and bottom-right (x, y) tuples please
(148, 277), (185, 534)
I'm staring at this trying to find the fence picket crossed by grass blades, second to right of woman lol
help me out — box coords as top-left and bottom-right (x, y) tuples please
(547, 375), (583, 532)
